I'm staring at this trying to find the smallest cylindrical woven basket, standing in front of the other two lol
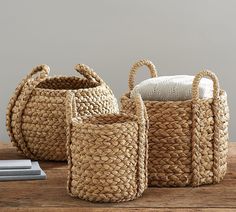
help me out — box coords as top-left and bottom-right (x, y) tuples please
(67, 93), (147, 202)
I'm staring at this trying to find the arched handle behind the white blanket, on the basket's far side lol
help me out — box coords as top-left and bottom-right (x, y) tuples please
(129, 59), (157, 91)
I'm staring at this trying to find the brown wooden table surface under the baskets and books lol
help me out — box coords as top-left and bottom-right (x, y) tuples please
(0, 143), (236, 212)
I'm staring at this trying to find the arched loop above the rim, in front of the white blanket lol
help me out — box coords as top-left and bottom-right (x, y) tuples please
(192, 70), (220, 101)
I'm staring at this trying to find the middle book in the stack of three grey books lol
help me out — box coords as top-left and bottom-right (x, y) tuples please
(0, 162), (41, 176)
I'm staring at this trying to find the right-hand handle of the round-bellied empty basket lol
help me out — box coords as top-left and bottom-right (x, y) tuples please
(75, 64), (104, 84)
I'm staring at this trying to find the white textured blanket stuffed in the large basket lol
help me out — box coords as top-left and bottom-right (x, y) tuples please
(131, 75), (213, 101)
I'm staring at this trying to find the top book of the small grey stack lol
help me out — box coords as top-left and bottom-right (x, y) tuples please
(0, 160), (32, 170)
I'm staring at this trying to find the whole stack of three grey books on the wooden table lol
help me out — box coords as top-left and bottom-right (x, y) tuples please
(0, 160), (46, 181)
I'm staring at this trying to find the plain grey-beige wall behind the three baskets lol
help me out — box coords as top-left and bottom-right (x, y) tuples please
(0, 0), (236, 141)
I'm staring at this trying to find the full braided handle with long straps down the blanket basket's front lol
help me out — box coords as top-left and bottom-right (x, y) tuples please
(192, 70), (220, 186)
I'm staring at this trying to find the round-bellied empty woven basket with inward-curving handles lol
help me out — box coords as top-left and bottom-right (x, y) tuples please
(7, 64), (118, 161)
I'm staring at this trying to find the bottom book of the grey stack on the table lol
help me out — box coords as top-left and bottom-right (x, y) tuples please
(0, 162), (47, 181)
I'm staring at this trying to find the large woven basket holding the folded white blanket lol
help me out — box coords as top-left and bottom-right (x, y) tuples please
(121, 60), (229, 186)
